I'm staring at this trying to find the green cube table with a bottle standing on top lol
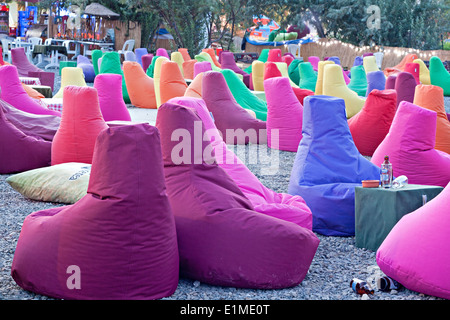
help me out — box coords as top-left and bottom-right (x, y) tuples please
(355, 184), (443, 251)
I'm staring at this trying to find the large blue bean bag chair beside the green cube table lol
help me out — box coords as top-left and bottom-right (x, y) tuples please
(288, 95), (380, 236)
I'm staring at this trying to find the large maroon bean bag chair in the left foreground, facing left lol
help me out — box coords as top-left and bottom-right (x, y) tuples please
(11, 124), (179, 300)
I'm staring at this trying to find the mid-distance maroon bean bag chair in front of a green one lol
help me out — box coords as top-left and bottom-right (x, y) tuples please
(202, 71), (267, 144)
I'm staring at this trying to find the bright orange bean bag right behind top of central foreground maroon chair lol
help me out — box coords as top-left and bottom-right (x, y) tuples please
(159, 61), (188, 104)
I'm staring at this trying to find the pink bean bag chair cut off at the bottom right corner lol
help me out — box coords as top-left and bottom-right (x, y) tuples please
(376, 184), (450, 299)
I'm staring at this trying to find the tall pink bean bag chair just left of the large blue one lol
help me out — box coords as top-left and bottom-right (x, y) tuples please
(264, 77), (303, 152)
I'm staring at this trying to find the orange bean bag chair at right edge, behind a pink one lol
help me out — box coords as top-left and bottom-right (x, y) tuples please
(413, 84), (450, 154)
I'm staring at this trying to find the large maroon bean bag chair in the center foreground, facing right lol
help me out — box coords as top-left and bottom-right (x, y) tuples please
(156, 102), (319, 289)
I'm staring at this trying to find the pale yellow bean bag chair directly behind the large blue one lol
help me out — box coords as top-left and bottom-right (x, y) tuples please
(323, 64), (366, 119)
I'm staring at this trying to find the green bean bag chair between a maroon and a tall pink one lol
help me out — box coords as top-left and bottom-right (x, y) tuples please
(221, 69), (267, 121)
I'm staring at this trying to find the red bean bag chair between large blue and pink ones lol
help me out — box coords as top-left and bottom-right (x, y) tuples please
(348, 89), (397, 156)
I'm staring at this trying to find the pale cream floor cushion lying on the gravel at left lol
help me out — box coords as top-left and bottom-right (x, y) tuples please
(6, 162), (91, 204)
